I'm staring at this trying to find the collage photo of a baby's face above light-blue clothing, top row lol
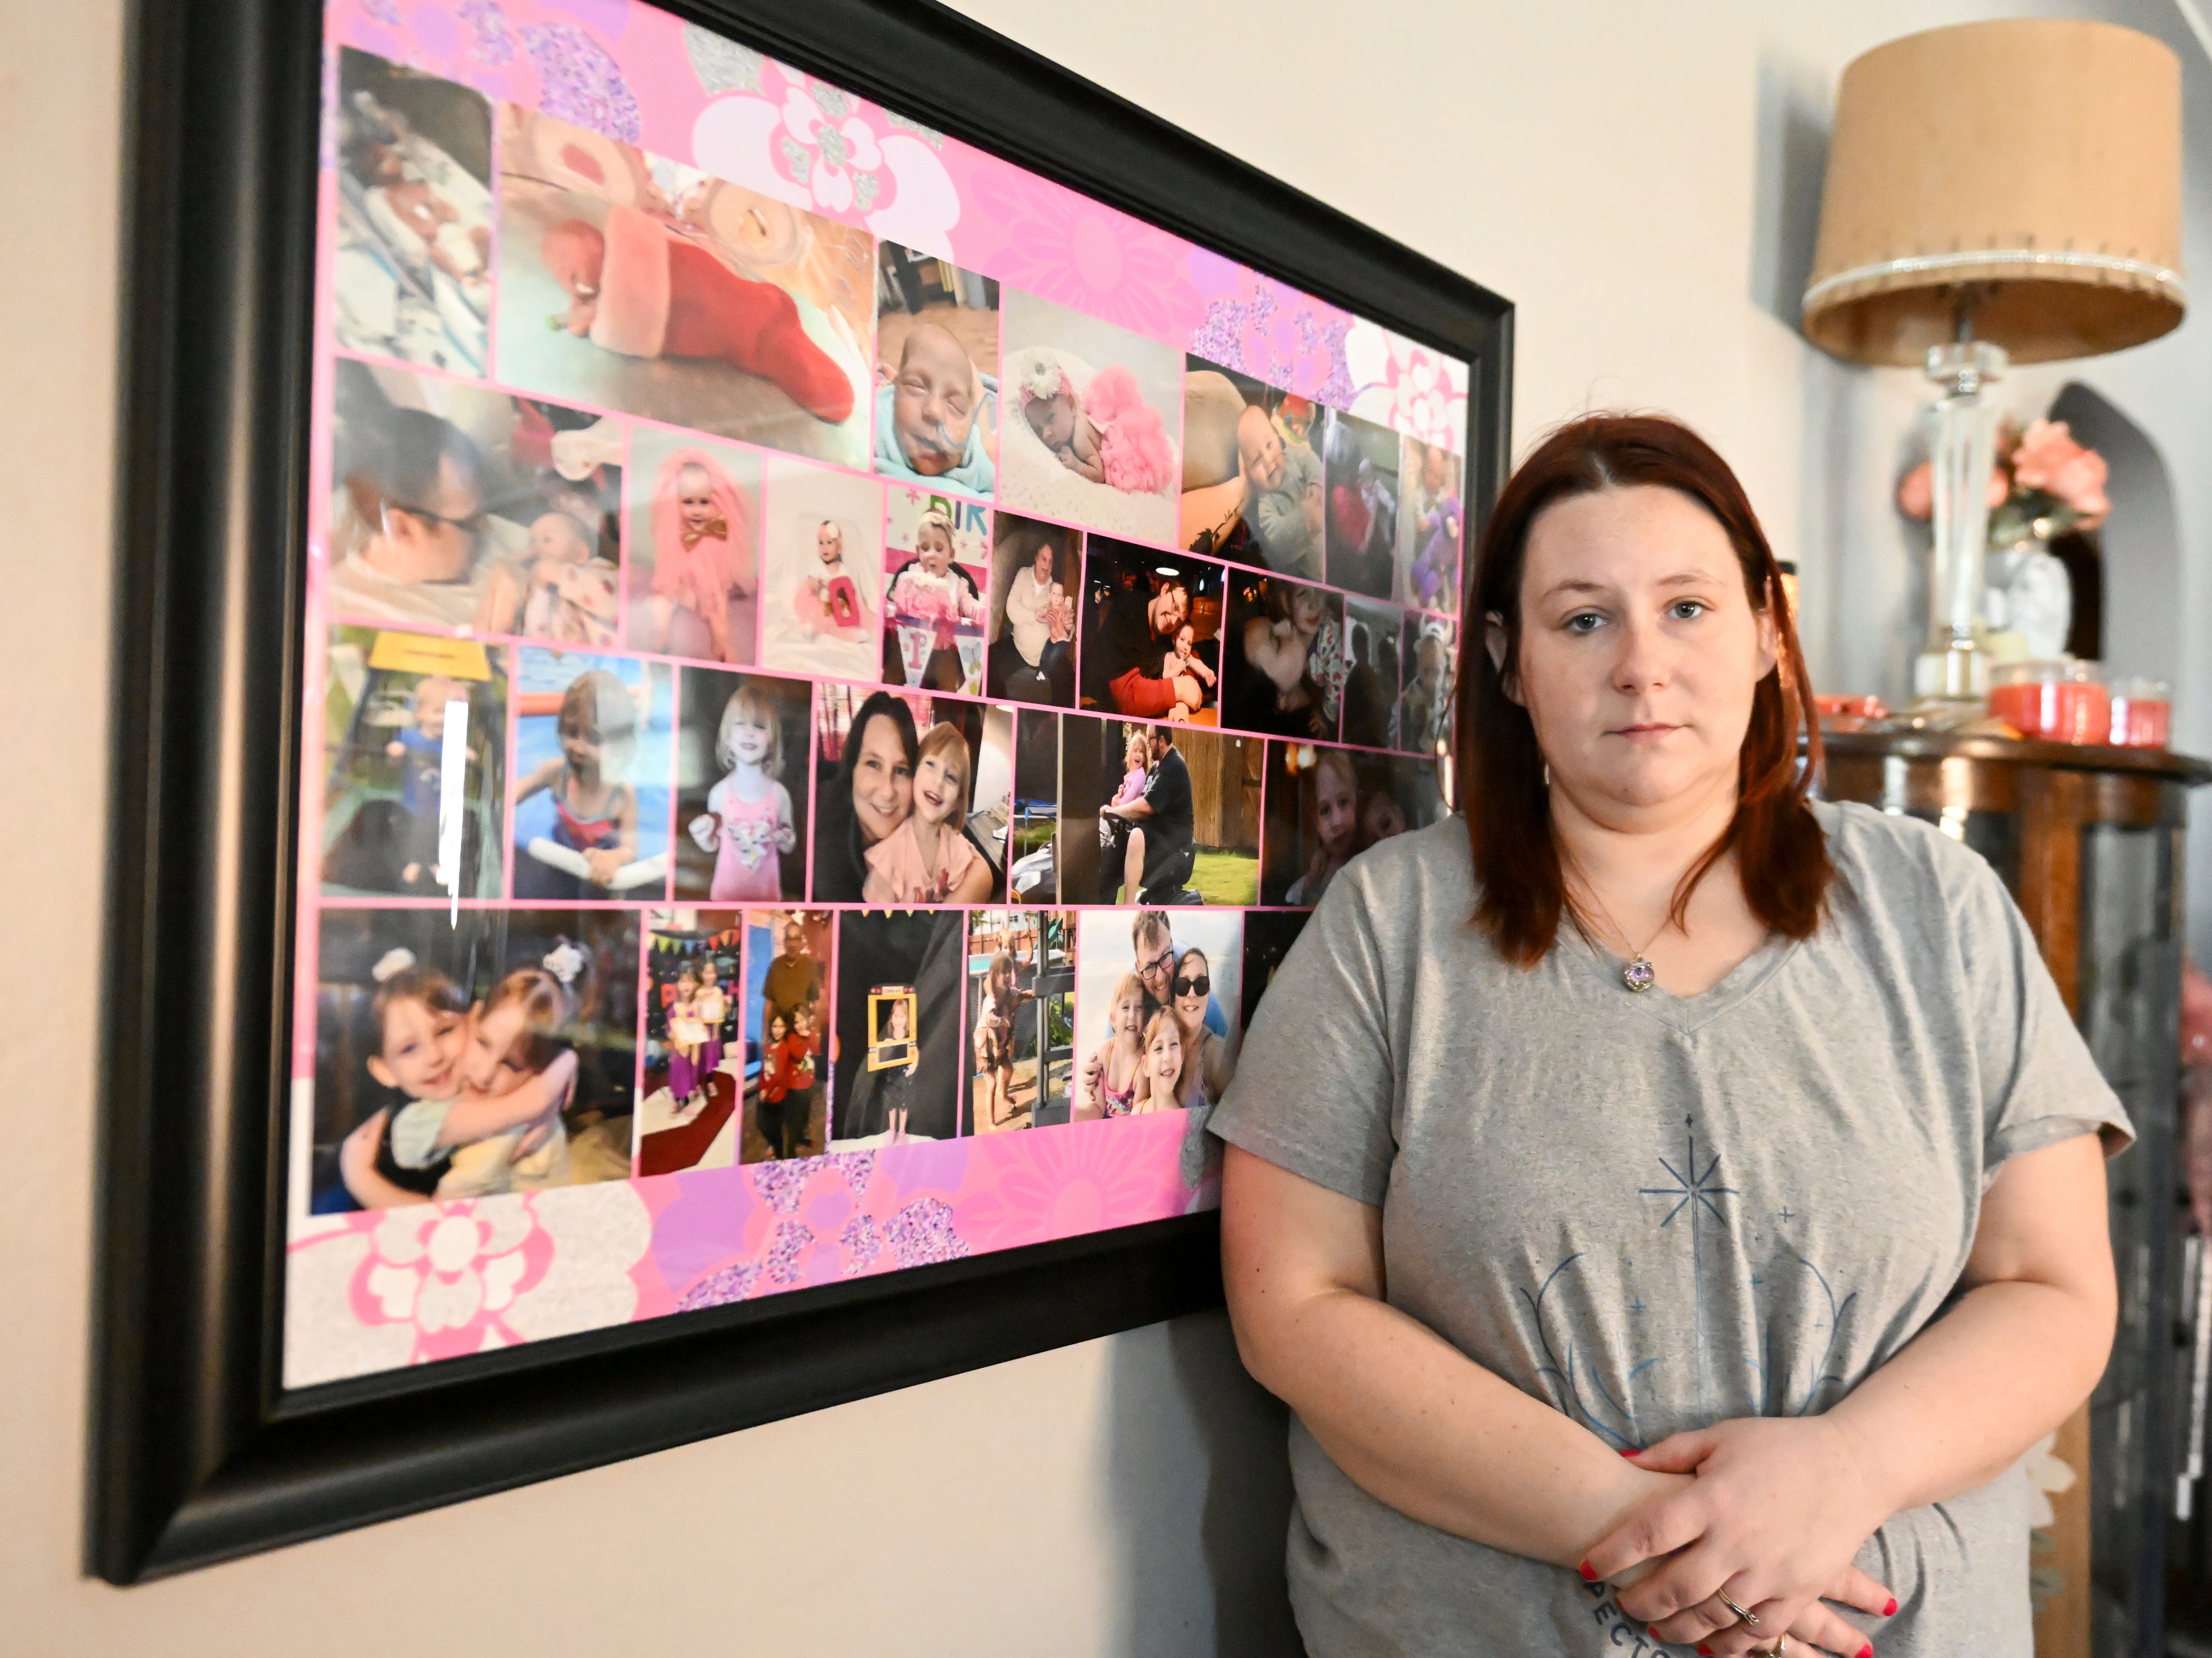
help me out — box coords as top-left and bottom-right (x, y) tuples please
(876, 241), (998, 500)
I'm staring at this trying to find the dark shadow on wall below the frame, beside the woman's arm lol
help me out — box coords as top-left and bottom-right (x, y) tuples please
(1102, 1313), (1305, 1658)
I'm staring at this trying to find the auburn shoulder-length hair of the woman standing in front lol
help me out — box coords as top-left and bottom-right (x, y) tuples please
(1455, 413), (1834, 968)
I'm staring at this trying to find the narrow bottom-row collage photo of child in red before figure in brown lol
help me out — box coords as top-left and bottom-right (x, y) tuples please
(739, 908), (836, 1163)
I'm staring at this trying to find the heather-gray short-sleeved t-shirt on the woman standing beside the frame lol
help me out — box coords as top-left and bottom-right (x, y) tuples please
(1212, 805), (2130, 1658)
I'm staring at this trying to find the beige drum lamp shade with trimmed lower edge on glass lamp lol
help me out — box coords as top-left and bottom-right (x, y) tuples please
(1805, 18), (2185, 365)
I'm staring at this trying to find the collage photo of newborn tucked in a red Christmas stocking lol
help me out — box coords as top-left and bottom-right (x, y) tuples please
(496, 104), (876, 471)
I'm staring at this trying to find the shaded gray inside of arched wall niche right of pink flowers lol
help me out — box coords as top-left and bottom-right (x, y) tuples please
(2050, 380), (2183, 685)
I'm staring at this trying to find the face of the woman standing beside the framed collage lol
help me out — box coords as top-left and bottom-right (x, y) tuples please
(1493, 484), (1776, 811)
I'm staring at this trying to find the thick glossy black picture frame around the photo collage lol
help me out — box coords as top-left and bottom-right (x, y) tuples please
(99, 0), (1513, 1583)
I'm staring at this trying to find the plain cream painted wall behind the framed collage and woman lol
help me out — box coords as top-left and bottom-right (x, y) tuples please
(13, 0), (2212, 1658)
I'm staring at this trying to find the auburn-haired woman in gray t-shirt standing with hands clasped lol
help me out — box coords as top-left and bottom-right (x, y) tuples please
(1214, 416), (2128, 1658)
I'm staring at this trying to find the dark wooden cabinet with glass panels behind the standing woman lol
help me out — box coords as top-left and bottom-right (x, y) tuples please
(1823, 732), (2212, 1658)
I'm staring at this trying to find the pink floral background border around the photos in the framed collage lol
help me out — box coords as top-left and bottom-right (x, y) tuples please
(285, 0), (1466, 1386)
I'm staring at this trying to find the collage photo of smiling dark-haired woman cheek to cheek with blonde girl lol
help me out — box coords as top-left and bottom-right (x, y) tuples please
(814, 685), (1013, 904)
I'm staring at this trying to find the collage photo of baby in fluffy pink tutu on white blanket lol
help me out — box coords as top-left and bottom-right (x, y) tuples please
(998, 290), (1183, 546)
